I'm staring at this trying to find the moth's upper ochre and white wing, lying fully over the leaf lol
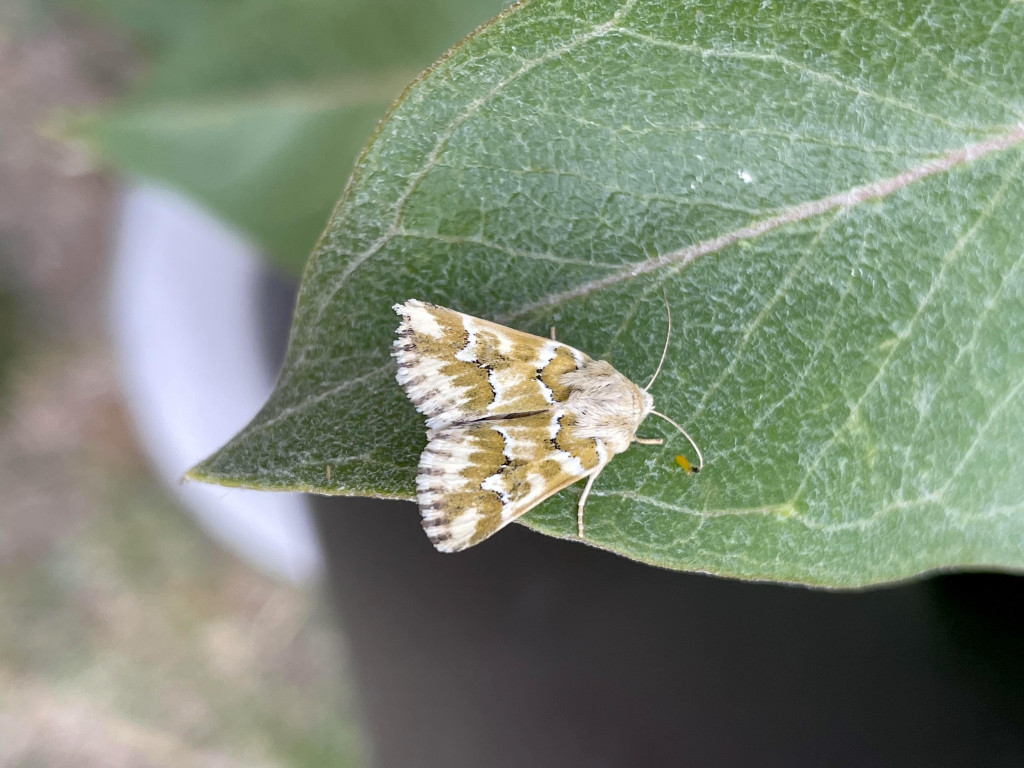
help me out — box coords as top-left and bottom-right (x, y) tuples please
(392, 299), (590, 430)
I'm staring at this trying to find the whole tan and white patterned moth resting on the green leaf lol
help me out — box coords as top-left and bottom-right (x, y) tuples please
(391, 299), (703, 552)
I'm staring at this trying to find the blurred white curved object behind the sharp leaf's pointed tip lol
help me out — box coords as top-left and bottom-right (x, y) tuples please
(112, 186), (323, 582)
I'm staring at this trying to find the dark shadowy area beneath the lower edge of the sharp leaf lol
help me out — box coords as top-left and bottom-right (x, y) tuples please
(316, 499), (1024, 768)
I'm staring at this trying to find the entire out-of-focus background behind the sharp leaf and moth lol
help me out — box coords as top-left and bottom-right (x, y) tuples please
(0, 0), (1024, 768)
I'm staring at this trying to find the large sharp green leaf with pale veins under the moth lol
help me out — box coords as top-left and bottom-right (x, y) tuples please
(191, 0), (1024, 587)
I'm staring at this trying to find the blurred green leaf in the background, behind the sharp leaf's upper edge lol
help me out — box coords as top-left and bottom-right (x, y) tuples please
(77, 0), (512, 274)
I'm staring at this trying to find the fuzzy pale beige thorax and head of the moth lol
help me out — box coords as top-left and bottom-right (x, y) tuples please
(563, 360), (654, 454)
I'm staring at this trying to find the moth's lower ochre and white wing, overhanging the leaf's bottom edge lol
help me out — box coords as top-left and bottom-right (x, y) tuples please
(416, 409), (607, 552)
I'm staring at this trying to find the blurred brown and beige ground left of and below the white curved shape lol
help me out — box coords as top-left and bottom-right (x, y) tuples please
(0, 0), (376, 766)
